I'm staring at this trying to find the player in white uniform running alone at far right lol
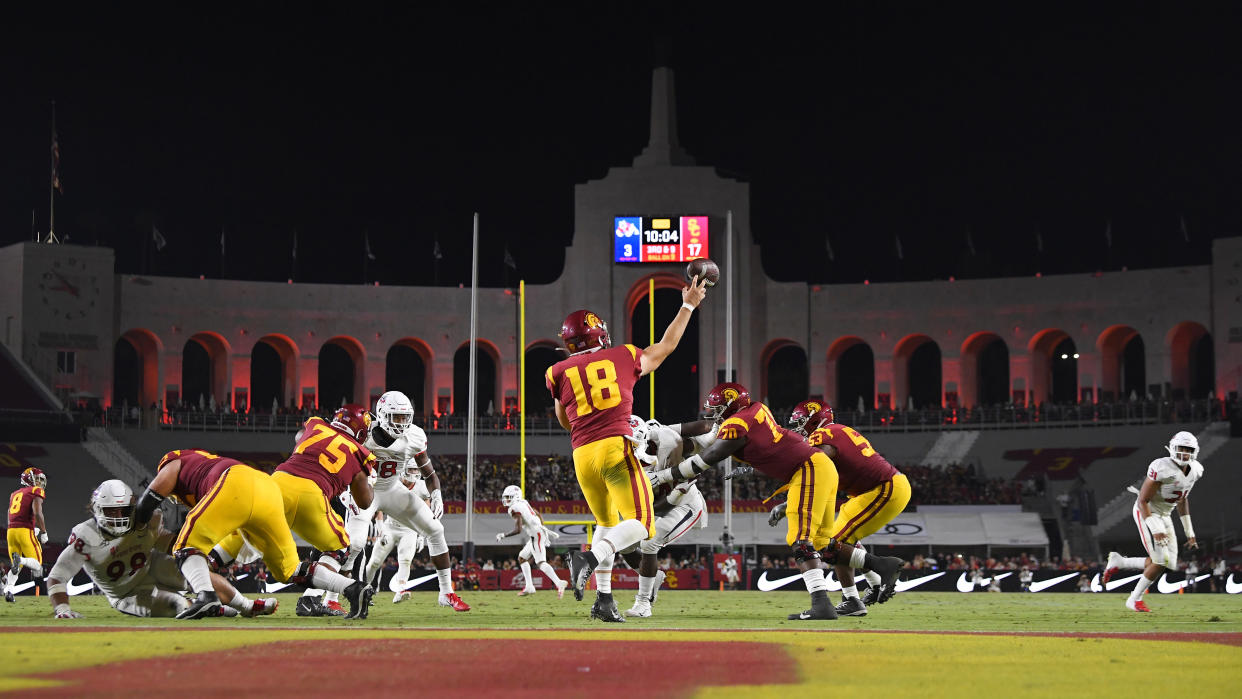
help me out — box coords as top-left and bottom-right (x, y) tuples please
(1100, 432), (1203, 612)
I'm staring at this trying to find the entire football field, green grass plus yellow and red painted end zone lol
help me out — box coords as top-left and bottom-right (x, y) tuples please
(0, 591), (1242, 698)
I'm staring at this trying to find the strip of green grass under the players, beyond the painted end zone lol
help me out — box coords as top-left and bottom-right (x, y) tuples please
(0, 591), (1242, 633)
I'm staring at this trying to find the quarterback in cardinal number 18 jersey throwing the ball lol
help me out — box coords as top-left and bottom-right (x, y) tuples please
(545, 276), (707, 622)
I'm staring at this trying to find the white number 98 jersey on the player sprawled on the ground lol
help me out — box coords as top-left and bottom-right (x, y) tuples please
(51, 519), (165, 600)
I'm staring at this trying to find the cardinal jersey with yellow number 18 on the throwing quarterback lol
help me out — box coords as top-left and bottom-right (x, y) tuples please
(546, 345), (642, 449)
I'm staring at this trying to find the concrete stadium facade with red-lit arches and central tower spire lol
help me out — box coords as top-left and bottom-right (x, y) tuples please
(0, 68), (1242, 412)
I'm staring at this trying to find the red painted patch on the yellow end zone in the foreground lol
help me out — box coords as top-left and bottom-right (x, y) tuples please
(17, 638), (799, 699)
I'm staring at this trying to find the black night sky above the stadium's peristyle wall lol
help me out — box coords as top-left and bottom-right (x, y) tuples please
(0, 2), (1242, 286)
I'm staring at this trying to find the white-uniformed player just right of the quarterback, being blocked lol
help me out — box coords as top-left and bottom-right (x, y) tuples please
(625, 415), (715, 617)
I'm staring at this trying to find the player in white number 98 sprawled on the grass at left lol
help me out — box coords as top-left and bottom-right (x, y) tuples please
(47, 480), (277, 618)
